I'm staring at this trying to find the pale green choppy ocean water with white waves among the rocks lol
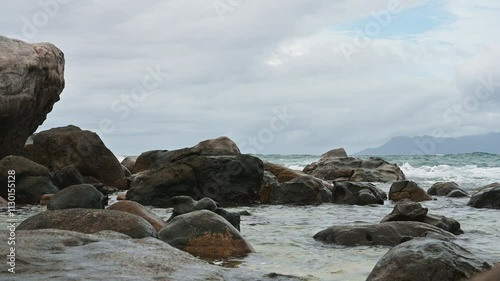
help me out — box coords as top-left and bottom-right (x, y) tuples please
(6, 153), (500, 281)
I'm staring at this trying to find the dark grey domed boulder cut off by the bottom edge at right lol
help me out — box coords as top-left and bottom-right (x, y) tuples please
(366, 239), (491, 281)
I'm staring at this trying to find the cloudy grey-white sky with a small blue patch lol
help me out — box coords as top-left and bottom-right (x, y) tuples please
(0, 0), (500, 155)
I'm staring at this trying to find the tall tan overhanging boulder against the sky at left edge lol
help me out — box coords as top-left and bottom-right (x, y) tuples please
(0, 36), (64, 159)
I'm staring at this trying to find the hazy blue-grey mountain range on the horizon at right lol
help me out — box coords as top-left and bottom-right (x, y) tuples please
(355, 133), (500, 155)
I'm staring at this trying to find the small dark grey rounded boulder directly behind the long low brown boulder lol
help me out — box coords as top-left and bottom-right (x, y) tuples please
(47, 184), (108, 210)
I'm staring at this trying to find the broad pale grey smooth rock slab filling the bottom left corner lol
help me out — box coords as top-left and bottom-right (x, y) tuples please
(0, 229), (223, 281)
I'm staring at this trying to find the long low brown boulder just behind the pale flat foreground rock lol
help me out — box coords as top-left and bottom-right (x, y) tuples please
(16, 209), (156, 238)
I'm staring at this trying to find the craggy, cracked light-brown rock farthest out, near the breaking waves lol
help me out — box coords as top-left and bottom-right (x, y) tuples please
(303, 157), (405, 182)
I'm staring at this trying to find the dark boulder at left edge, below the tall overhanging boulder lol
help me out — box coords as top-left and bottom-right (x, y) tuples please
(0, 156), (59, 204)
